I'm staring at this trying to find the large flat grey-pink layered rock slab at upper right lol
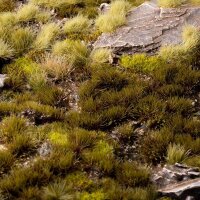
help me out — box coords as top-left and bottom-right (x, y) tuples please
(94, 2), (200, 55)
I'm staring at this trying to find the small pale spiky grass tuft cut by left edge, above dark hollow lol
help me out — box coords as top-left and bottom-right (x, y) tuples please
(0, 39), (14, 60)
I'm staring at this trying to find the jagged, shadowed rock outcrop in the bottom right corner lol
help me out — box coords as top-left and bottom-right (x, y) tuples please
(152, 163), (200, 200)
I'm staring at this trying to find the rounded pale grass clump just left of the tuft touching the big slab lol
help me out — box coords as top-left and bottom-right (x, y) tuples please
(63, 15), (90, 34)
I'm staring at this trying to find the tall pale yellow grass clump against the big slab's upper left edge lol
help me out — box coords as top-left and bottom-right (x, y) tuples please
(96, 0), (131, 32)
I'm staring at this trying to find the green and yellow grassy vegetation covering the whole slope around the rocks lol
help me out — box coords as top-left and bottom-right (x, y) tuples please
(0, 0), (200, 200)
